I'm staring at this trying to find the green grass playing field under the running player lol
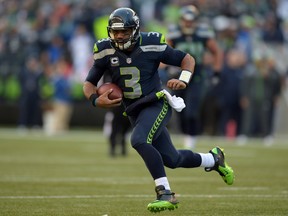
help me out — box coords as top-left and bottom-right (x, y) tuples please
(0, 128), (288, 216)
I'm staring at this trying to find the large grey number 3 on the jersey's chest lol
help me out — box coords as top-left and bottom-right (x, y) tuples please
(120, 67), (142, 99)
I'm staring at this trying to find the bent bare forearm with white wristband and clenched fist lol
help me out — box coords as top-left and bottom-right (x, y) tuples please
(167, 53), (195, 90)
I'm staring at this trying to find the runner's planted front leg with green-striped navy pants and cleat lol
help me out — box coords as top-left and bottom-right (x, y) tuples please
(131, 100), (178, 212)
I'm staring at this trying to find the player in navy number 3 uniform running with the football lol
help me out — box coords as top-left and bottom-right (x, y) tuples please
(83, 8), (234, 212)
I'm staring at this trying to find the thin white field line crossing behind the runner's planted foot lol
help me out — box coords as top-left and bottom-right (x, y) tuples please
(0, 194), (288, 199)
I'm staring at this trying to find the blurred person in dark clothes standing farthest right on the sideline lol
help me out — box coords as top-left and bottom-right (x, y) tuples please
(241, 46), (281, 145)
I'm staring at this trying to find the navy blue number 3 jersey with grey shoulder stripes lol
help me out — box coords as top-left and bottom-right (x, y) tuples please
(86, 32), (186, 105)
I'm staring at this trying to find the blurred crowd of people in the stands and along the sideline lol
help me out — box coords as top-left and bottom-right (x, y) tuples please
(0, 0), (288, 143)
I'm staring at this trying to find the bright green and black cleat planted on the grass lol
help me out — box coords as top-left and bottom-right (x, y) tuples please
(147, 185), (179, 213)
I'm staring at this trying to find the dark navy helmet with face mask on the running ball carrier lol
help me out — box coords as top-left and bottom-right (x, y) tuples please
(107, 8), (140, 50)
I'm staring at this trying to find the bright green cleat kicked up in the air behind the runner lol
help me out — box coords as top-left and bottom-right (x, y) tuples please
(205, 147), (234, 185)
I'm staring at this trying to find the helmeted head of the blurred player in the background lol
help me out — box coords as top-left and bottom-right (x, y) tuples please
(180, 5), (199, 35)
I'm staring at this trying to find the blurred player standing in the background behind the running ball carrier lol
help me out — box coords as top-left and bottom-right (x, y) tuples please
(167, 5), (223, 149)
